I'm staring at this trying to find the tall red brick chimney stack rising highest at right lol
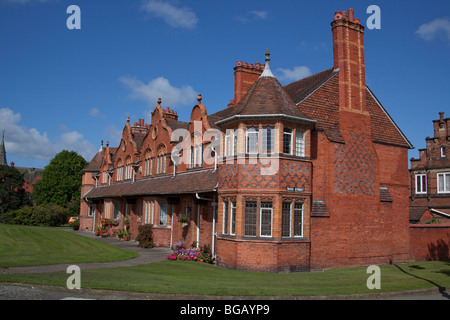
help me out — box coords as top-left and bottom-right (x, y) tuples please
(331, 9), (367, 113)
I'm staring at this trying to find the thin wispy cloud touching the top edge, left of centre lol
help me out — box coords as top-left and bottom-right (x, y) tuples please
(142, 0), (199, 29)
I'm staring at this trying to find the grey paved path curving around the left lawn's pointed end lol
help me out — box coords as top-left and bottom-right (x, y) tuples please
(0, 230), (172, 274)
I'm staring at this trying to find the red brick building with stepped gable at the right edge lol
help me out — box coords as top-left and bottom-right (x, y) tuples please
(410, 112), (450, 225)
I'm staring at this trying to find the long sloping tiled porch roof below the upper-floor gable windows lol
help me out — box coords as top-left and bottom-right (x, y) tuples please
(83, 169), (217, 200)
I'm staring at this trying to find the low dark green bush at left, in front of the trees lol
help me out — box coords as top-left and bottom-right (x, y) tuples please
(3, 204), (68, 227)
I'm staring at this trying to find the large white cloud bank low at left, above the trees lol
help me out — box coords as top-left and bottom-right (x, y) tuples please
(0, 108), (97, 161)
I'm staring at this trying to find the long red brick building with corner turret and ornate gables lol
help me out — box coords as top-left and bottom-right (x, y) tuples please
(80, 9), (412, 272)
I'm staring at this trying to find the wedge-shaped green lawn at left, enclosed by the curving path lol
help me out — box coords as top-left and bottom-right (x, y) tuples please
(0, 223), (137, 268)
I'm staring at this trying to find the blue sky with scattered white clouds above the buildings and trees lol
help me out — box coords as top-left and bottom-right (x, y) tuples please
(0, 0), (450, 168)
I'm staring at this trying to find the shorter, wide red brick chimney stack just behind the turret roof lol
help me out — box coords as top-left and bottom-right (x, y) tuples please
(228, 61), (264, 107)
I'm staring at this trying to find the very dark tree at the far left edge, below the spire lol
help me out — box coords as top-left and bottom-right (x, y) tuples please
(0, 166), (29, 214)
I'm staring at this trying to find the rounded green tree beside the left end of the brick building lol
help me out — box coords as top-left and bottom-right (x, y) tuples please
(33, 150), (88, 208)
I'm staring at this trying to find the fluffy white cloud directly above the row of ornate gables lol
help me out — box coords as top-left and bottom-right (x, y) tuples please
(120, 77), (197, 107)
